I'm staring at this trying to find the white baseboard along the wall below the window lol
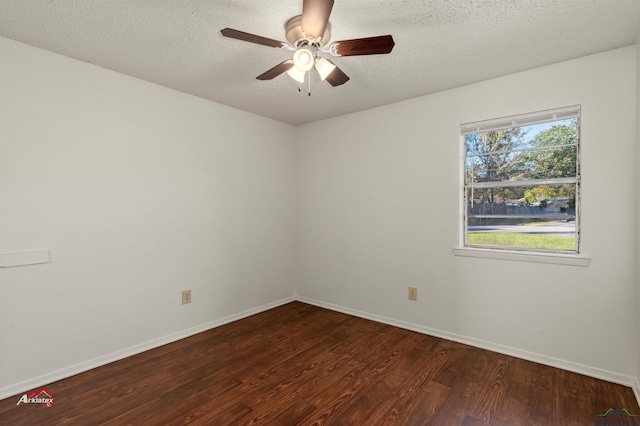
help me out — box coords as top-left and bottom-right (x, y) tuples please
(296, 296), (640, 390)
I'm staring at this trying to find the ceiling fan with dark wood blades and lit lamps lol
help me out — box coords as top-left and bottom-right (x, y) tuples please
(220, 0), (395, 90)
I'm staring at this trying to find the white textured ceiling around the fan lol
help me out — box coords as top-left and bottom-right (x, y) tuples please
(0, 0), (640, 125)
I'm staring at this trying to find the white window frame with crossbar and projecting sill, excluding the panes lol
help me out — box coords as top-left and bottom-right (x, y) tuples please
(454, 105), (589, 266)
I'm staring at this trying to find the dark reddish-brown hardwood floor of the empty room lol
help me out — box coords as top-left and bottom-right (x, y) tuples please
(0, 302), (640, 426)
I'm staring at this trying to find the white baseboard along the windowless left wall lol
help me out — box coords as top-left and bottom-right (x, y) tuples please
(0, 297), (296, 399)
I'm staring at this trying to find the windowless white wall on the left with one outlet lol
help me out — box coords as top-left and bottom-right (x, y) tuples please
(0, 38), (294, 398)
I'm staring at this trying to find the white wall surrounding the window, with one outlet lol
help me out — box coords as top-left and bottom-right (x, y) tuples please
(296, 47), (638, 384)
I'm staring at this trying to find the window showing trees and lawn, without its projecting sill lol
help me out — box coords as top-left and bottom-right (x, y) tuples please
(461, 106), (580, 254)
